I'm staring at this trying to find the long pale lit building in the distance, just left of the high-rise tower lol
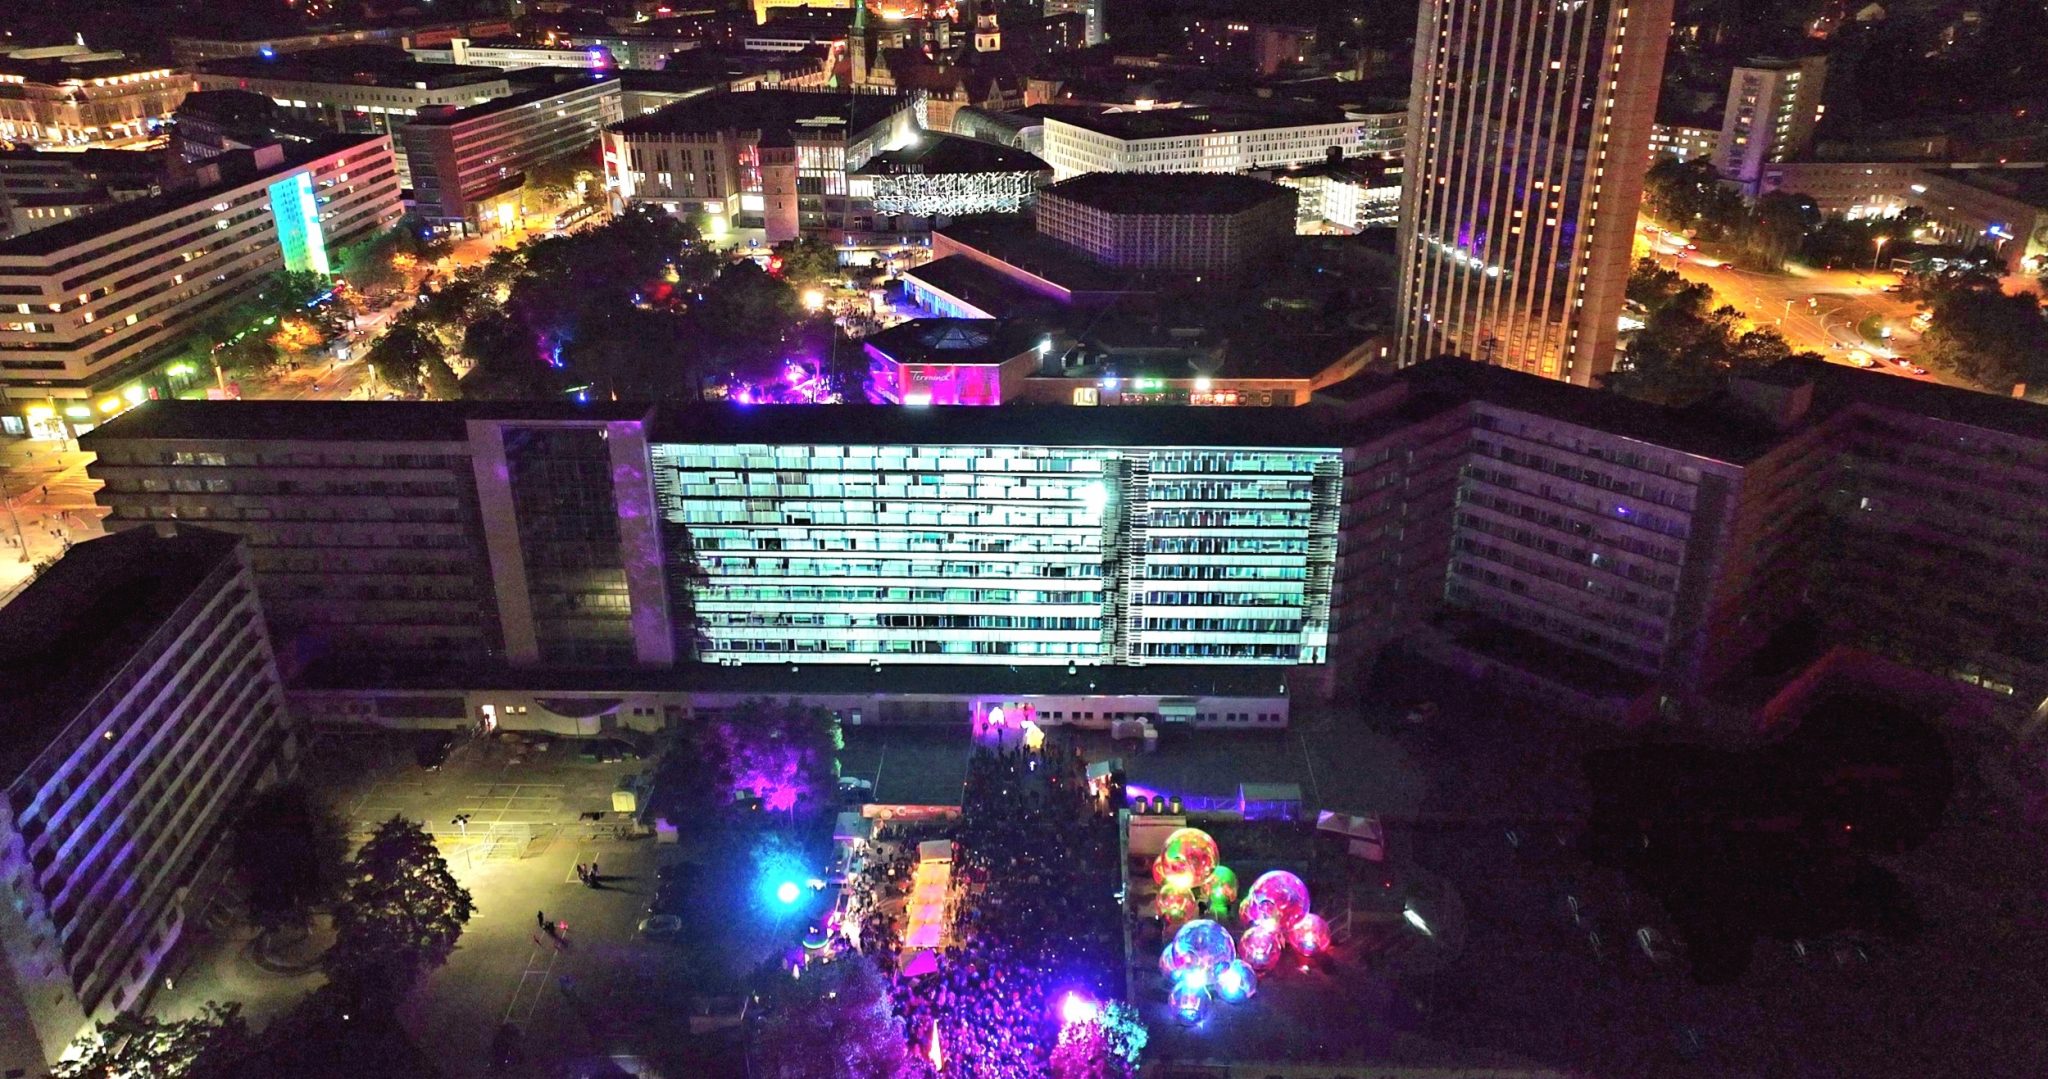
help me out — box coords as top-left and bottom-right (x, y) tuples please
(1040, 106), (1364, 180)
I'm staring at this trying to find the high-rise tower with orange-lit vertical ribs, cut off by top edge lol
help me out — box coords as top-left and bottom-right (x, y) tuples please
(1397, 0), (1671, 385)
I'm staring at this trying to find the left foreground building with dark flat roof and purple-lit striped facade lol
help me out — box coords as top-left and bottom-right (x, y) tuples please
(0, 522), (299, 1075)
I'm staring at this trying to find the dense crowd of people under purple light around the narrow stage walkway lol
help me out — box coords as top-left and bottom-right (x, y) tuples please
(856, 743), (1122, 1079)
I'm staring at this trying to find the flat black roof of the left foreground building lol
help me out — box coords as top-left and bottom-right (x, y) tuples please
(0, 526), (240, 782)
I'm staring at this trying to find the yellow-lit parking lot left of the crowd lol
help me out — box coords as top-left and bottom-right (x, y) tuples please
(307, 735), (694, 1077)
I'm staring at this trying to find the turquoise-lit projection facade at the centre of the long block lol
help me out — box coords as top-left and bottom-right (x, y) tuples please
(653, 442), (1337, 663)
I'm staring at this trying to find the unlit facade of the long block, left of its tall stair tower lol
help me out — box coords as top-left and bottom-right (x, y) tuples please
(88, 401), (502, 667)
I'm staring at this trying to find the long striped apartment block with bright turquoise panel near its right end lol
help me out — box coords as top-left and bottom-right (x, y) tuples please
(0, 135), (403, 438)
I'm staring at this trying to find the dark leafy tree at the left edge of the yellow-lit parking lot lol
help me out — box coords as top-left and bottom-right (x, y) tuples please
(326, 817), (475, 993)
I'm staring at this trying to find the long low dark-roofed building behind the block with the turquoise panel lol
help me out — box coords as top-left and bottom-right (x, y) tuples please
(193, 45), (512, 188)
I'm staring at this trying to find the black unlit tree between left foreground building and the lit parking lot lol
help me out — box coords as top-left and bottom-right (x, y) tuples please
(233, 784), (348, 925)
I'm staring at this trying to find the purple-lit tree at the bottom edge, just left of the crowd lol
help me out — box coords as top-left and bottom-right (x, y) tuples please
(754, 952), (918, 1079)
